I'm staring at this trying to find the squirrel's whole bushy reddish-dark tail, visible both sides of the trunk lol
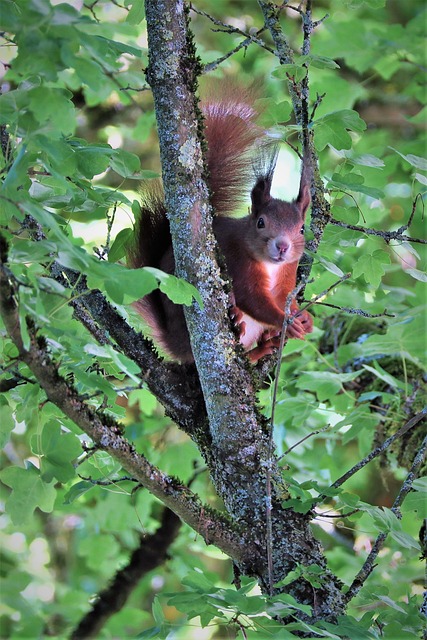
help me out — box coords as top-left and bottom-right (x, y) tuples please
(127, 89), (263, 362)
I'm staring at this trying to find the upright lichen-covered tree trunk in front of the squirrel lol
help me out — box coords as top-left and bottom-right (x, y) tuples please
(146, 0), (342, 619)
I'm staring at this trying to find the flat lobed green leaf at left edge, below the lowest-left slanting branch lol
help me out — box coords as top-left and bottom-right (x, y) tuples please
(0, 463), (56, 525)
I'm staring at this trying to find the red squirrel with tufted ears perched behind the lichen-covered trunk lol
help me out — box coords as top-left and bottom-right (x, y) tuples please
(128, 92), (313, 363)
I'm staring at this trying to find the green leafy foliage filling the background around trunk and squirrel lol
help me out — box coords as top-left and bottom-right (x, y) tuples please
(0, 0), (427, 639)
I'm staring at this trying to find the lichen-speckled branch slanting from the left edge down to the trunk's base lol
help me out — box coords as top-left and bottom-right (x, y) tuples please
(0, 264), (245, 559)
